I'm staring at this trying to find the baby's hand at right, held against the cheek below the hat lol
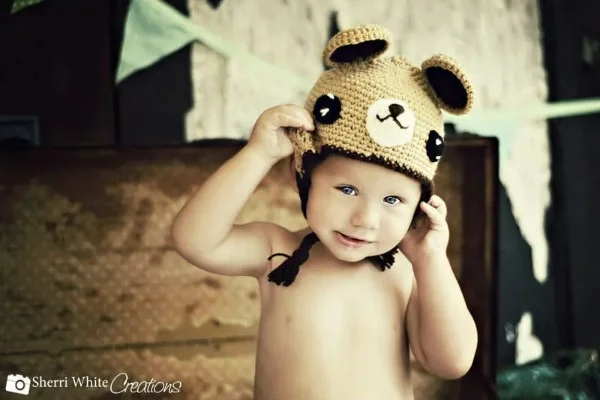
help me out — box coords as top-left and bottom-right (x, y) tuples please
(399, 195), (450, 265)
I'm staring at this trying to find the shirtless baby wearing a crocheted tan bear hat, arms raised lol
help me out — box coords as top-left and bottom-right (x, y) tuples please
(172, 25), (477, 400)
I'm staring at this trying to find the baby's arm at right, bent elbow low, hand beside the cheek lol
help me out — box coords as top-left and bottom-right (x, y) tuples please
(401, 196), (478, 379)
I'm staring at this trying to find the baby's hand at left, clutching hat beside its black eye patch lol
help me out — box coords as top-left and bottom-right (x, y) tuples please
(248, 104), (315, 162)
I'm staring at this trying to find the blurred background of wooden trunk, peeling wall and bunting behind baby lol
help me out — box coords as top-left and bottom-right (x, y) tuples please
(0, 0), (600, 399)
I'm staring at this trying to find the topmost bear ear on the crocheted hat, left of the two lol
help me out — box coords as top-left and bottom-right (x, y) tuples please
(323, 25), (391, 67)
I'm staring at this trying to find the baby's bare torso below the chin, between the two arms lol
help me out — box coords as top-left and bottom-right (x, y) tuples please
(256, 258), (408, 399)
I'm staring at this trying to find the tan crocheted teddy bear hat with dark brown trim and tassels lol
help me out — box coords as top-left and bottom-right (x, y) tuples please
(269, 25), (473, 285)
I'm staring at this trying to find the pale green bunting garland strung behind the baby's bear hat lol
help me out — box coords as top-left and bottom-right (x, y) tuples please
(117, 0), (600, 131)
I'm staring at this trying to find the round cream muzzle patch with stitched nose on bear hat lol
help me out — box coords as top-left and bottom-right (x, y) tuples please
(367, 99), (416, 147)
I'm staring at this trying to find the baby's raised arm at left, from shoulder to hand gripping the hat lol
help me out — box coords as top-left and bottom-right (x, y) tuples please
(171, 105), (314, 277)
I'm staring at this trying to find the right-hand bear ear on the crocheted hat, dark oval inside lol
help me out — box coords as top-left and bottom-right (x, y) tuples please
(421, 54), (473, 115)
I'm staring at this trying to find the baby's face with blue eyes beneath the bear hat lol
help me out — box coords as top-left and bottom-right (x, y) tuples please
(307, 155), (421, 262)
